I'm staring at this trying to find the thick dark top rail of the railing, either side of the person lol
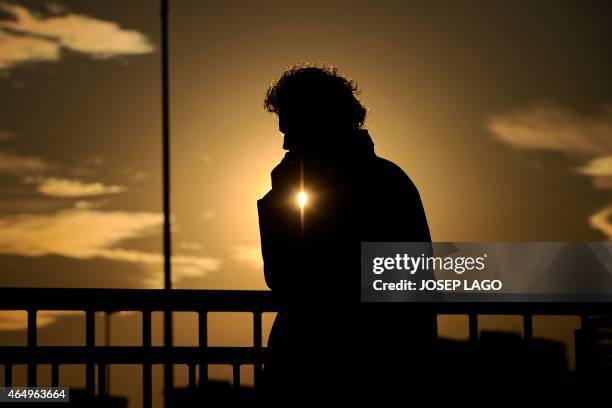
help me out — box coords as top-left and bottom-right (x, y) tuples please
(0, 288), (612, 316)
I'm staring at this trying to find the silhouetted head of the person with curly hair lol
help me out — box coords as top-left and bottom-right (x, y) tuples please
(264, 64), (366, 150)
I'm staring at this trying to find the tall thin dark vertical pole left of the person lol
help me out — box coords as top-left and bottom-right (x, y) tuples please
(161, 0), (174, 404)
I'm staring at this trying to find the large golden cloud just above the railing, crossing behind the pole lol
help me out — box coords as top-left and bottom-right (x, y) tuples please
(0, 209), (221, 279)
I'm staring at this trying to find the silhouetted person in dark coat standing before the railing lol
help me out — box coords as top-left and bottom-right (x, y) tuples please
(257, 65), (435, 401)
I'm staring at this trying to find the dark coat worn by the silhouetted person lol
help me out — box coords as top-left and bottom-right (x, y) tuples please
(257, 130), (435, 395)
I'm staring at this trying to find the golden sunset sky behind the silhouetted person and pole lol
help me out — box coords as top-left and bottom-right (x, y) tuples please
(0, 0), (612, 404)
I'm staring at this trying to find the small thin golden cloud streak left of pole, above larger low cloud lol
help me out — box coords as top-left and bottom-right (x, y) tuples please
(24, 177), (127, 197)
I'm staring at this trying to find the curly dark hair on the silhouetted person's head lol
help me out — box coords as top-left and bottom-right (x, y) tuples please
(264, 63), (366, 129)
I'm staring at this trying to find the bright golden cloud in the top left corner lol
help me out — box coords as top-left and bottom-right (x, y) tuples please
(0, 3), (154, 69)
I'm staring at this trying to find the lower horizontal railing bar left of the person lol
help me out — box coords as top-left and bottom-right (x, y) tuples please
(0, 346), (266, 365)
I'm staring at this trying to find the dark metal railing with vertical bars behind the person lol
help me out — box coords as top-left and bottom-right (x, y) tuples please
(0, 288), (612, 407)
